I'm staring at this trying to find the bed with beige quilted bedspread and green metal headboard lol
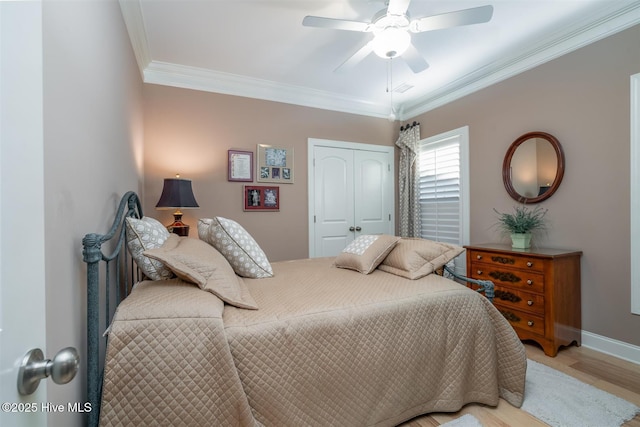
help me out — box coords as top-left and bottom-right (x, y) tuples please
(84, 193), (526, 426)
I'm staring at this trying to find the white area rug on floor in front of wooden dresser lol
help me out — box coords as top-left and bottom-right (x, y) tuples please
(522, 360), (640, 427)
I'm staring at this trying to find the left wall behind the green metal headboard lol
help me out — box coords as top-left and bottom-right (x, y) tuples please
(41, 1), (143, 427)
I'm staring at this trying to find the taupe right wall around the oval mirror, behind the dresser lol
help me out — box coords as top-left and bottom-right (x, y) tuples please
(410, 26), (640, 345)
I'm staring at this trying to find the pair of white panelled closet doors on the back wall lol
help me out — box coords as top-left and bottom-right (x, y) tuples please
(309, 141), (395, 257)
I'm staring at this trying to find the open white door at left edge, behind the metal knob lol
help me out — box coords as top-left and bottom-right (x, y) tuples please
(0, 0), (48, 427)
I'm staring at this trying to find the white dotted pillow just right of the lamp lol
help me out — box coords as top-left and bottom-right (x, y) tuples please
(198, 216), (273, 279)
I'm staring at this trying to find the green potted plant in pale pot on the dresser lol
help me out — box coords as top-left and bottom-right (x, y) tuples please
(494, 205), (547, 249)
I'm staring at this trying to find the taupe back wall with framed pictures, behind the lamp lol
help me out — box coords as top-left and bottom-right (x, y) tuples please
(144, 85), (397, 261)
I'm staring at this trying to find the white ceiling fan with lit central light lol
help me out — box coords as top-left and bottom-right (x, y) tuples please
(302, 0), (493, 73)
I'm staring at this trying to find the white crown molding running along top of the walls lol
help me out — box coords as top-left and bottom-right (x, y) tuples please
(119, 0), (640, 121)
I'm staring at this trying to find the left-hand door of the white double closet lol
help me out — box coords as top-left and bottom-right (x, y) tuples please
(314, 147), (354, 256)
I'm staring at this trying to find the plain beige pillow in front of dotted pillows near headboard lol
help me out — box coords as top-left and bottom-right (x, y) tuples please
(144, 234), (258, 310)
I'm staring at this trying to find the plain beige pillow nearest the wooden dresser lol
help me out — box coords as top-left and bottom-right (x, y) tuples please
(378, 238), (464, 280)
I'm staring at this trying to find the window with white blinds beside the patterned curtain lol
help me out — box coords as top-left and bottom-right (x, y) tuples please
(420, 126), (469, 274)
